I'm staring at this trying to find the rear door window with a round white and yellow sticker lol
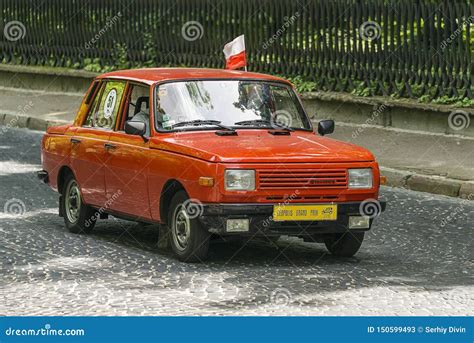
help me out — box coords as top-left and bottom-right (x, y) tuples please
(85, 81), (126, 129)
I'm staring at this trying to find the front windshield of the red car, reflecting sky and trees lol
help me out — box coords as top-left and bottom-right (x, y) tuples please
(155, 80), (311, 130)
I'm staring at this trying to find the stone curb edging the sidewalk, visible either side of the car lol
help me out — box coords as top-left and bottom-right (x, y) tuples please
(0, 114), (474, 200)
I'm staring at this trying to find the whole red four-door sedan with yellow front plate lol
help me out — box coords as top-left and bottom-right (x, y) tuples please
(38, 68), (385, 261)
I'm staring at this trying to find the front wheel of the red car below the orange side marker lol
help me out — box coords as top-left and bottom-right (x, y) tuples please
(168, 191), (210, 262)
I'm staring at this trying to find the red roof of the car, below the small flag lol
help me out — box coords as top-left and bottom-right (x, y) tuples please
(97, 68), (291, 85)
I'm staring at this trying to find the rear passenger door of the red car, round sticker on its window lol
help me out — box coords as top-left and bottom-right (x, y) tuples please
(71, 81), (126, 207)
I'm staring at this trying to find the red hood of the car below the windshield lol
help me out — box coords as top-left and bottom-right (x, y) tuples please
(150, 130), (374, 163)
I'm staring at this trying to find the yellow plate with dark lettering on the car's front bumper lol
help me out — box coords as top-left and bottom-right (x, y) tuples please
(273, 204), (337, 221)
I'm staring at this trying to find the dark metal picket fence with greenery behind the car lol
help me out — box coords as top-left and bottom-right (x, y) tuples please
(0, 0), (474, 99)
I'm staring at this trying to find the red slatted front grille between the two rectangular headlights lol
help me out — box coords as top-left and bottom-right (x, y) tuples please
(258, 169), (347, 189)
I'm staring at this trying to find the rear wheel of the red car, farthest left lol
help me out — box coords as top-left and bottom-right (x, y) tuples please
(59, 174), (99, 233)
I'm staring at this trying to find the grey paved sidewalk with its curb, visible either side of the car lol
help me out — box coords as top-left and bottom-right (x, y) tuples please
(0, 88), (474, 200)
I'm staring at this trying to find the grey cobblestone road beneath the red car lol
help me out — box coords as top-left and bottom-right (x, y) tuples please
(0, 127), (474, 315)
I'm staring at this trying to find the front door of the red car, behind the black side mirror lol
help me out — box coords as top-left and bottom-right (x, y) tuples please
(105, 83), (151, 220)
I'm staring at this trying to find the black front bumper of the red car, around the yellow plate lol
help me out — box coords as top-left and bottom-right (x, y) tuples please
(199, 201), (386, 236)
